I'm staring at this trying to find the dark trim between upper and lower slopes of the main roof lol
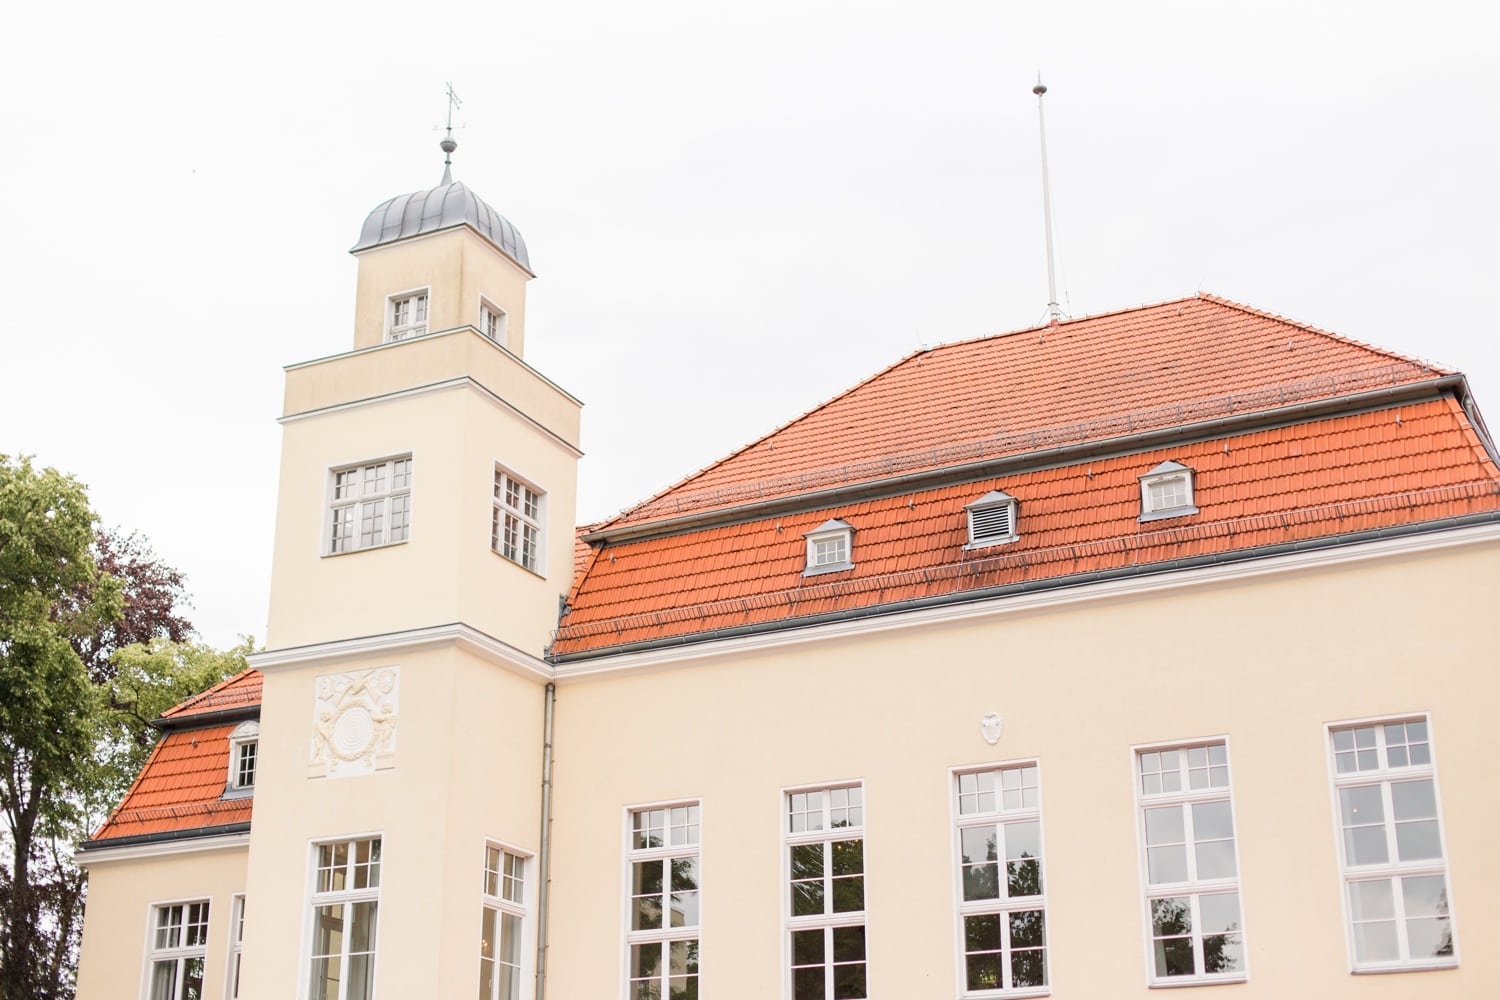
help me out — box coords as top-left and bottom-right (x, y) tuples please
(579, 375), (1464, 544)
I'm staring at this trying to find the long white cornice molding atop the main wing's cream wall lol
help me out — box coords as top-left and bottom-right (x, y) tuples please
(555, 522), (1500, 684)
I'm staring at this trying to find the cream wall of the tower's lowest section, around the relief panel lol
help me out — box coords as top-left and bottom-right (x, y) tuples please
(245, 648), (543, 1000)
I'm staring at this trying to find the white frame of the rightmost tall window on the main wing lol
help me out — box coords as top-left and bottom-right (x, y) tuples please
(1323, 712), (1460, 973)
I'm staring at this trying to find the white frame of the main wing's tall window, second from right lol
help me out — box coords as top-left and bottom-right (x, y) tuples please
(1130, 735), (1250, 987)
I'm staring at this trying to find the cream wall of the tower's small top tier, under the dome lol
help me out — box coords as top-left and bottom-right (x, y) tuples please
(354, 226), (531, 355)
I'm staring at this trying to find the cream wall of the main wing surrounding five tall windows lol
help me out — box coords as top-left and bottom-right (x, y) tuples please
(549, 543), (1500, 1000)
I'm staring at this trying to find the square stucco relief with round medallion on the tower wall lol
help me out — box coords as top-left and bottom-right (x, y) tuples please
(308, 667), (401, 778)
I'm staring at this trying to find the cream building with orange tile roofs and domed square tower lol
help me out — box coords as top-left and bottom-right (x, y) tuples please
(80, 164), (1500, 1000)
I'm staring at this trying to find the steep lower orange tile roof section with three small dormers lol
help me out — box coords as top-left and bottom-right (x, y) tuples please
(552, 388), (1500, 658)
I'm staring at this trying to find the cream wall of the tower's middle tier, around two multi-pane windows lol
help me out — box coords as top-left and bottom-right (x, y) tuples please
(267, 367), (576, 655)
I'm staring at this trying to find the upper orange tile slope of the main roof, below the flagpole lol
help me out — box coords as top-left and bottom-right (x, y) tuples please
(605, 295), (1451, 529)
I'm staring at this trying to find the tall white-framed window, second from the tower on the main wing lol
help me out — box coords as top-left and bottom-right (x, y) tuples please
(785, 784), (867, 1000)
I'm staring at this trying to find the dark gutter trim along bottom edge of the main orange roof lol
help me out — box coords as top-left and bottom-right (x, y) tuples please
(548, 510), (1500, 664)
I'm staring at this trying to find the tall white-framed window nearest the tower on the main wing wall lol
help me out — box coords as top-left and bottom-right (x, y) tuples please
(626, 802), (701, 1000)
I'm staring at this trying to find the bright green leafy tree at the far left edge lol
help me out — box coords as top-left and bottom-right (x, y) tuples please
(0, 456), (122, 1000)
